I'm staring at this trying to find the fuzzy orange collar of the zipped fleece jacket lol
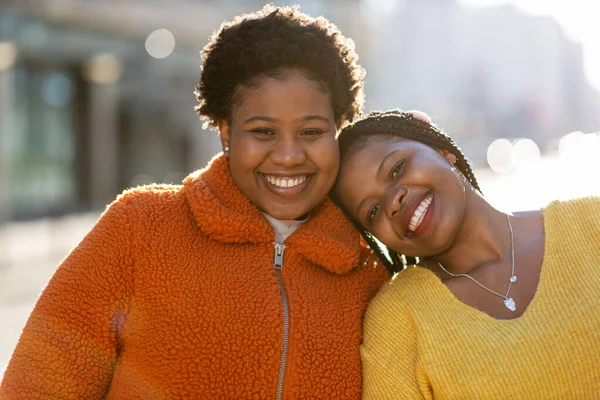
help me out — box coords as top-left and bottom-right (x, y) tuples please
(183, 154), (360, 274)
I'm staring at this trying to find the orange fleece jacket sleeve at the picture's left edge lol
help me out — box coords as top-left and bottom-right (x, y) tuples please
(0, 199), (133, 400)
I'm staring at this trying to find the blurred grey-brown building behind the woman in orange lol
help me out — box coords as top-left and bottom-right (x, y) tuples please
(0, 0), (360, 221)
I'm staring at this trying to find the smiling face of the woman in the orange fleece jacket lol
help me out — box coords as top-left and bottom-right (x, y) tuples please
(219, 70), (339, 220)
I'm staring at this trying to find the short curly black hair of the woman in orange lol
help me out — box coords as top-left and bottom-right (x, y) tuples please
(194, 5), (365, 128)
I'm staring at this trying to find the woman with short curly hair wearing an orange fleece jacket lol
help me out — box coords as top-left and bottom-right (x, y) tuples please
(5, 6), (398, 400)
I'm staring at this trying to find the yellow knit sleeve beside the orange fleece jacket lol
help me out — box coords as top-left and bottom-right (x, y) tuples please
(361, 287), (433, 400)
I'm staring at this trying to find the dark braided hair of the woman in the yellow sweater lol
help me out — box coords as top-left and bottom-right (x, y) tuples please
(331, 110), (481, 273)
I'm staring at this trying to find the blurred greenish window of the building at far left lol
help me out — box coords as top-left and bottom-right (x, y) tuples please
(8, 63), (76, 218)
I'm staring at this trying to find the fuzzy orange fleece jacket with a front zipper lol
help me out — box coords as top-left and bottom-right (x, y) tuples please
(0, 156), (387, 400)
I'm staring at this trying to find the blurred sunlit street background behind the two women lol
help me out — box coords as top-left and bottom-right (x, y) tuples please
(0, 0), (600, 375)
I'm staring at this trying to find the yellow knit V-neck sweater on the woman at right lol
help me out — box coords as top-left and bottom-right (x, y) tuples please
(362, 198), (600, 400)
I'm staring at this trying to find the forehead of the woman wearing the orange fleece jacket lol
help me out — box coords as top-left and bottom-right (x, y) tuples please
(232, 70), (333, 118)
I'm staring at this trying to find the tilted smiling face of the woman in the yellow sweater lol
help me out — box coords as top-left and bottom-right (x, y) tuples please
(335, 135), (466, 257)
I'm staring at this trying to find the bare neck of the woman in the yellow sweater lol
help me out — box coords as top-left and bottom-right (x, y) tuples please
(429, 191), (511, 274)
